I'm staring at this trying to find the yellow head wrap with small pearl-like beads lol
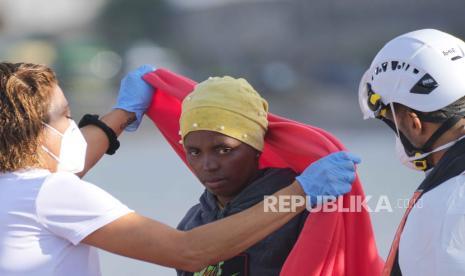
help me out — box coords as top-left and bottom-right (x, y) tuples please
(180, 76), (268, 151)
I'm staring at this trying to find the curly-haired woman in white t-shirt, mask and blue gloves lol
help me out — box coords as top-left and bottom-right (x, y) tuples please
(0, 63), (359, 276)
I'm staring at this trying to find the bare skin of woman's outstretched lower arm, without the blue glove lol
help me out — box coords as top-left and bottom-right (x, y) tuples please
(83, 182), (305, 272)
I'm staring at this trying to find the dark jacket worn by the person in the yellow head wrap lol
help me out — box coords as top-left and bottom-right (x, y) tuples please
(178, 168), (308, 276)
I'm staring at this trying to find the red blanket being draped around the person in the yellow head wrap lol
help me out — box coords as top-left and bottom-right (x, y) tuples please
(144, 69), (383, 276)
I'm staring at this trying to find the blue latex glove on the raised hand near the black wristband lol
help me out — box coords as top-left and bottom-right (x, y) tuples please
(113, 64), (155, 131)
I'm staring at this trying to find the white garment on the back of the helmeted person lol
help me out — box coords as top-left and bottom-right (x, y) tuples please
(399, 172), (465, 276)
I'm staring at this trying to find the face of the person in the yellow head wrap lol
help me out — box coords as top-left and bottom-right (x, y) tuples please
(184, 130), (259, 202)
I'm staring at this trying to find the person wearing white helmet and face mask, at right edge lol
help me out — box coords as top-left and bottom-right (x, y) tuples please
(359, 29), (465, 276)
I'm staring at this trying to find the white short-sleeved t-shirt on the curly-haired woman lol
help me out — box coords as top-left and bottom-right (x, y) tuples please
(0, 170), (132, 276)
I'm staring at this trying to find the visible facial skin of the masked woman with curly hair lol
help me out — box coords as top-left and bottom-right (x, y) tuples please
(41, 85), (71, 171)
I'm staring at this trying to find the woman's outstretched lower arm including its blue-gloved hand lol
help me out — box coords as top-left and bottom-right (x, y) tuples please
(83, 152), (360, 271)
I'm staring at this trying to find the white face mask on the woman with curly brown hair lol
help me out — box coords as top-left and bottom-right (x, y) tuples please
(42, 119), (87, 173)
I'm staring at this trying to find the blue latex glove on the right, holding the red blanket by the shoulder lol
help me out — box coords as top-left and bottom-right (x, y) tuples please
(296, 151), (361, 206)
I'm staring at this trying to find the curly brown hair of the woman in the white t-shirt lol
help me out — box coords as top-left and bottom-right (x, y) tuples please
(0, 62), (57, 172)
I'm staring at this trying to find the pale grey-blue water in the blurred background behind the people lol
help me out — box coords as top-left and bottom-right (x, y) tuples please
(85, 121), (423, 276)
